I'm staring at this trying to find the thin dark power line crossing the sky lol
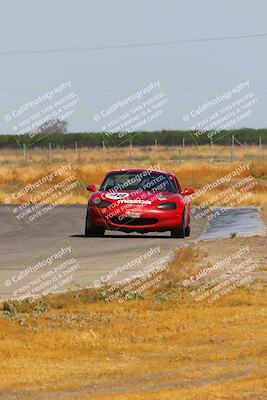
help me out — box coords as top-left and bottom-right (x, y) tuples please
(0, 33), (267, 56)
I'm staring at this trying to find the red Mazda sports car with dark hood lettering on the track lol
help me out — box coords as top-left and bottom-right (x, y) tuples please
(85, 169), (194, 238)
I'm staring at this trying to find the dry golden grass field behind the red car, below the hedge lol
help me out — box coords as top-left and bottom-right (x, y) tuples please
(0, 146), (267, 205)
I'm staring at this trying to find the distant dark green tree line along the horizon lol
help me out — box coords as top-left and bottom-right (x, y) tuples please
(0, 128), (267, 148)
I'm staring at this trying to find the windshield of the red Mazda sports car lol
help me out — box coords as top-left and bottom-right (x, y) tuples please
(100, 170), (177, 193)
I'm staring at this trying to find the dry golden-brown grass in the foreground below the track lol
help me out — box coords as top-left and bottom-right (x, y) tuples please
(0, 247), (267, 400)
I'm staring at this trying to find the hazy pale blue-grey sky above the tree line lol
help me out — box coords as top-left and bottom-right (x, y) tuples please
(0, 0), (267, 134)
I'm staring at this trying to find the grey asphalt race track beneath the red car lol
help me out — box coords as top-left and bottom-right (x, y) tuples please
(0, 205), (263, 299)
